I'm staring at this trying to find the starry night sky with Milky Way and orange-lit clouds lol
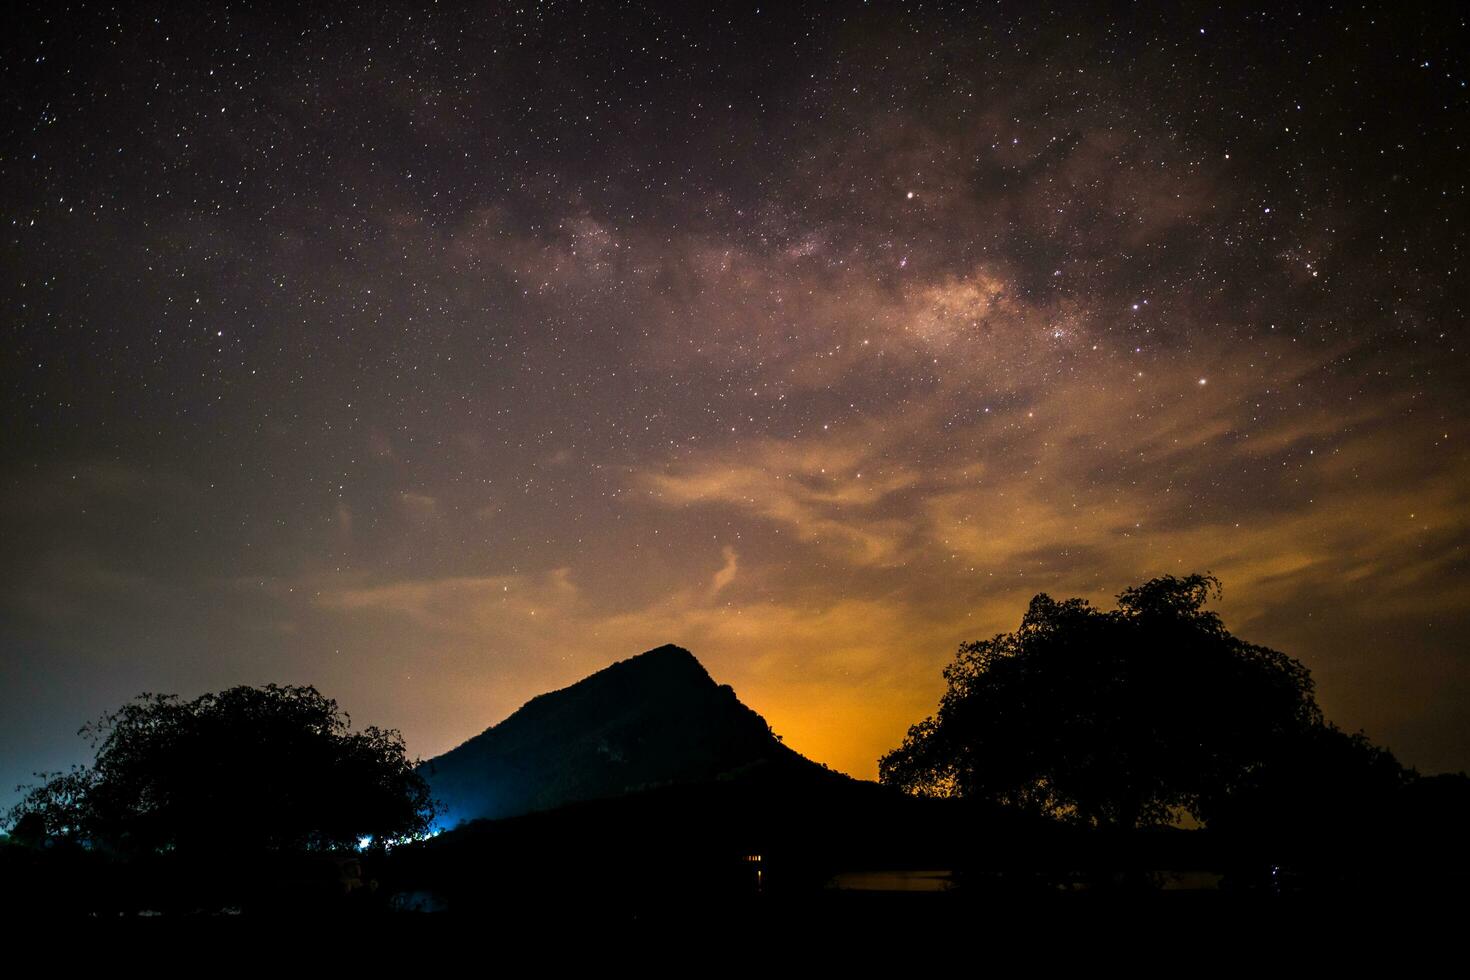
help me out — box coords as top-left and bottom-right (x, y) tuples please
(0, 3), (1470, 802)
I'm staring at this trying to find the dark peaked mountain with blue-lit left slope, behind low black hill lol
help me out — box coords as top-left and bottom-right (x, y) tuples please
(420, 645), (836, 827)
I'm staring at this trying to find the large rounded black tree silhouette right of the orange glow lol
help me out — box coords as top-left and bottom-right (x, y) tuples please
(879, 574), (1323, 829)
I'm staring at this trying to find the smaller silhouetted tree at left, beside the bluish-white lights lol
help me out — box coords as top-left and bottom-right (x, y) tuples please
(9, 685), (434, 855)
